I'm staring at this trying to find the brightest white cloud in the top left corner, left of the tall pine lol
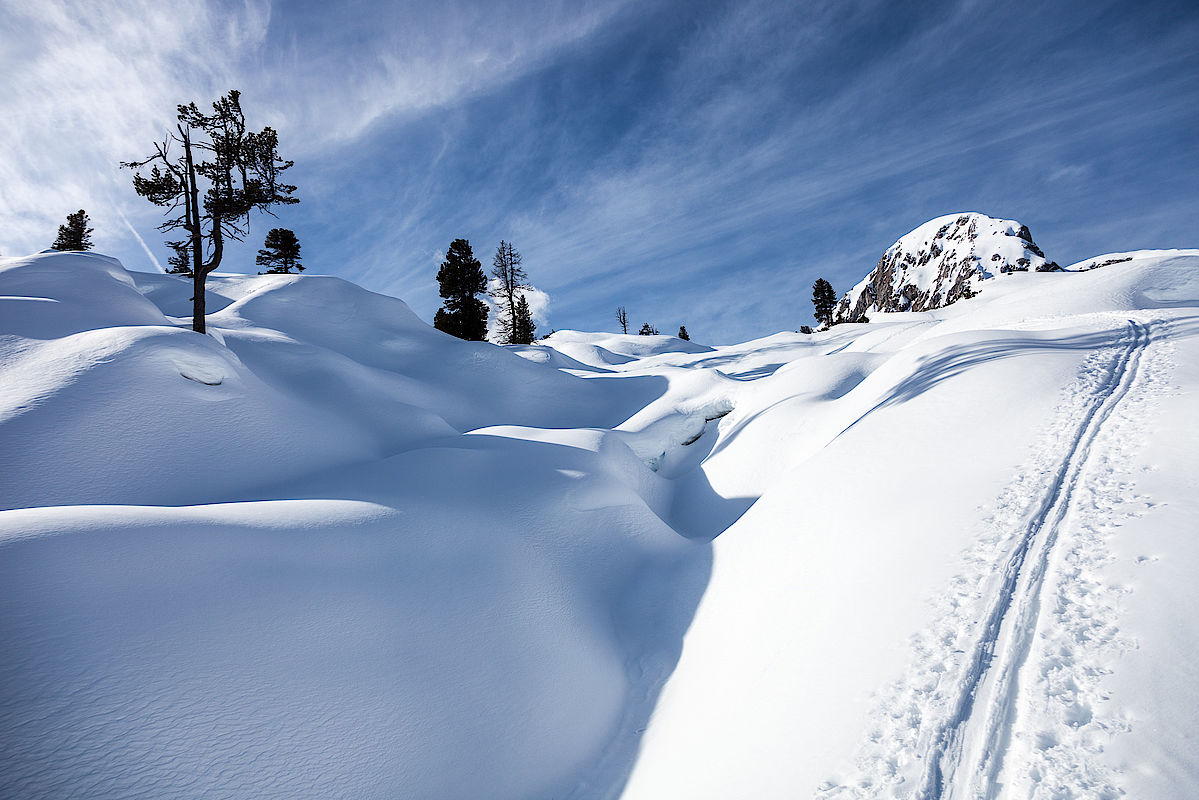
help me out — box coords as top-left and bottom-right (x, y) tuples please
(0, 0), (267, 252)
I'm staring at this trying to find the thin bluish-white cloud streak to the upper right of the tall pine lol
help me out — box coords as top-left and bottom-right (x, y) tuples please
(239, 0), (629, 152)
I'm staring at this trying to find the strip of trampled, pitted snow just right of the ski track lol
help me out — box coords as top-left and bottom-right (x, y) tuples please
(1001, 321), (1173, 800)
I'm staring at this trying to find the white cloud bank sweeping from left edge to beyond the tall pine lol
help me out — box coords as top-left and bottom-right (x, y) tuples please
(0, 0), (623, 260)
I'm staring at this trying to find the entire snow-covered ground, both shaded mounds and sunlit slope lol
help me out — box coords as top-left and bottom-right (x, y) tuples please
(0, 251), (1199, 800)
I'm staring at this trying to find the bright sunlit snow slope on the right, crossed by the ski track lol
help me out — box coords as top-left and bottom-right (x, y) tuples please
(623, 251), (1199, 799)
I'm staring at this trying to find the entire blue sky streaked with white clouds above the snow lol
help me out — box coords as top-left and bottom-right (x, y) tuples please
(0, 0), (1199, 342)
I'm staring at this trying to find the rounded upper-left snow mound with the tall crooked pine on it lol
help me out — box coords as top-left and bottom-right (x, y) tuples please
(0, 253), (653, 507)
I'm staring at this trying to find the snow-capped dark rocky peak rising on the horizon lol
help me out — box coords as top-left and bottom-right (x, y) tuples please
(835, 212), (1061, 323)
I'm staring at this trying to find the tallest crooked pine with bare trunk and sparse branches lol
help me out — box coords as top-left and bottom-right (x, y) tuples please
(121, 90), (300, 333)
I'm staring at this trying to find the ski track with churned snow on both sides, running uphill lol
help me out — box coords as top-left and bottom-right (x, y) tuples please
(817, 319), (1170, 800)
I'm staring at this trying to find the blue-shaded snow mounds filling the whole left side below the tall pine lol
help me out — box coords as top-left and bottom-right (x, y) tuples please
(0, 254), (706, 800)
